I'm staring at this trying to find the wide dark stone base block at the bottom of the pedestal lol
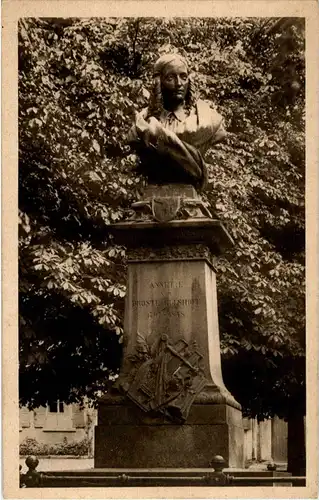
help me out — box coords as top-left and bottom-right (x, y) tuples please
(94, 403), (244, 468)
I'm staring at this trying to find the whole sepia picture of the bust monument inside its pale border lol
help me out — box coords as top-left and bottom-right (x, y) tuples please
(2, 2), (316, 498)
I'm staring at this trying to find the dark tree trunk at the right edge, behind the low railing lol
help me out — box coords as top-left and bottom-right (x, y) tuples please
(287, 416), (306, 476)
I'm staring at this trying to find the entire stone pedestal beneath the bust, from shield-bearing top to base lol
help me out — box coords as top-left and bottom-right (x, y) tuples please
(95, 186), (243, 468)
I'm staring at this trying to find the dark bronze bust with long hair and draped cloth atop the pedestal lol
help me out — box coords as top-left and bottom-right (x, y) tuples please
(128, 54), (226, 190)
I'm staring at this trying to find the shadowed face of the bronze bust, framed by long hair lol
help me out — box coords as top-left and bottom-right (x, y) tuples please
(161, 61), (188, 101)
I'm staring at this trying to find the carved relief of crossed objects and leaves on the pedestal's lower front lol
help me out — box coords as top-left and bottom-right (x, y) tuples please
(119, 335), (207, 423)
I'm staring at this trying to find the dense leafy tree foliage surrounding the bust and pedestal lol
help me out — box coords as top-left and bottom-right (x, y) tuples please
(19, 18), (305, 418)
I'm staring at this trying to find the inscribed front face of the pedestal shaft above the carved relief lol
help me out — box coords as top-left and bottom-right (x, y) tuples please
(127, 261), (206, 348)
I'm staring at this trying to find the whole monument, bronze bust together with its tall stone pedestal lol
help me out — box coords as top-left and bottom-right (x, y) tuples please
(95, 54), (243, 469)
